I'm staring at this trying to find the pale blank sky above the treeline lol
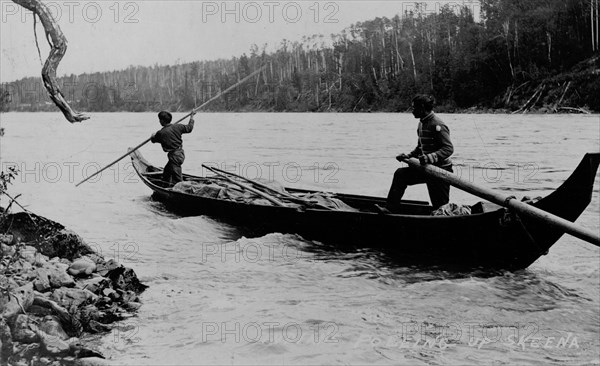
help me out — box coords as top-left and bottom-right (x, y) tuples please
(0, 0), (479, 82)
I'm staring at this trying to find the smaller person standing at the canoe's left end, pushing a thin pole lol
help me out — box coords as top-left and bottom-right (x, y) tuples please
(150, 111), (196, 185)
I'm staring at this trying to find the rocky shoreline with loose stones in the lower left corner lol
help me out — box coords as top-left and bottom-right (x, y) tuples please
(0, 212), (147, 365)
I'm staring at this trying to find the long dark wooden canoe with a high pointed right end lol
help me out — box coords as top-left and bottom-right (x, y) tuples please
(131, 151), (600, 271)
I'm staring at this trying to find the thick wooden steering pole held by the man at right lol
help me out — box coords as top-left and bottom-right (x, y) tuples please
(404, 158), (600, 246)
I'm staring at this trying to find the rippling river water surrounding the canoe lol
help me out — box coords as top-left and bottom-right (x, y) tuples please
(0, 113), (600, 365)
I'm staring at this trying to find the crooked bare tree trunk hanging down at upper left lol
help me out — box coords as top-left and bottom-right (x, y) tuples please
(13, 0), (90, 123)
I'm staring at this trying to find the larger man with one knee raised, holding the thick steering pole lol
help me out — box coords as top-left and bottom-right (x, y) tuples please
(387, 95), (454, 212)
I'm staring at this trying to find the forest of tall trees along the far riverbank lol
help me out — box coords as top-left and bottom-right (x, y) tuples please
(0, 0), (600, 112)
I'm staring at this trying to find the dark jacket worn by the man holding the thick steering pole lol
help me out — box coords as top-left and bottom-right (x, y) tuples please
(409, 112), (454, 166)
